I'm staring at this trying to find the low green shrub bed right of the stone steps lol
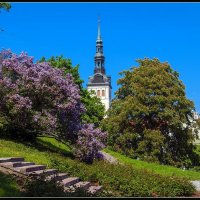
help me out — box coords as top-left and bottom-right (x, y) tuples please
(52, 160), (195, 197)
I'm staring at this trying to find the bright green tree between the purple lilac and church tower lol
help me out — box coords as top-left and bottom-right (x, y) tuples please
(39, 55), (105, 127)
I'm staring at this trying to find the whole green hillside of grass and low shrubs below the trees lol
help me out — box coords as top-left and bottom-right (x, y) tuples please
(0, 137), (200, 197)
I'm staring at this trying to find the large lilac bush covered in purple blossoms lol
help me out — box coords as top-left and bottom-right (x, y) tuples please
(0, 50), (106, 161)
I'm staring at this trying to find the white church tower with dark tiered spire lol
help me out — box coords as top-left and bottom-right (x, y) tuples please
(87, 19), (112, 111)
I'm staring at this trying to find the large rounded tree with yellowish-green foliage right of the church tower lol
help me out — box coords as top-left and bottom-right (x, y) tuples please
(102, 58), (197, 167)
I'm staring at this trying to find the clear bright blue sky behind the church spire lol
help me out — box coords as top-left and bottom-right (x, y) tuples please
(0, 2), (200, 112)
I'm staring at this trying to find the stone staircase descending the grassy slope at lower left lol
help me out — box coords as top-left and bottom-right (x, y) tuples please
(0, 157), (102, 194)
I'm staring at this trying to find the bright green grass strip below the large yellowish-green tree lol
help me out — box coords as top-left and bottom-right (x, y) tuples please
(104, 149), (200, 180)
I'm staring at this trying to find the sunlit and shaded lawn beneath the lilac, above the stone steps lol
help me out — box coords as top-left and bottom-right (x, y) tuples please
(0, 137), (73, 168)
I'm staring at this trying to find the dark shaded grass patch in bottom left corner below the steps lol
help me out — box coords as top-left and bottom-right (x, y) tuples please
(0, 172), (22, 197)
